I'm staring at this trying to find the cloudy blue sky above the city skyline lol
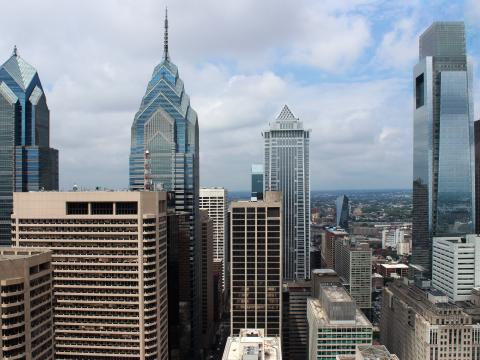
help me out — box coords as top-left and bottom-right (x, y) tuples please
(0, 0), (480, 191)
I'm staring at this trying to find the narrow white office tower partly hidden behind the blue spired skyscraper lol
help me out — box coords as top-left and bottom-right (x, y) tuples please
(199, 188), (228, 286)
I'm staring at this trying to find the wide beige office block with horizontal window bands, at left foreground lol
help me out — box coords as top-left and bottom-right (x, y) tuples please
(12, 191), (168, 360)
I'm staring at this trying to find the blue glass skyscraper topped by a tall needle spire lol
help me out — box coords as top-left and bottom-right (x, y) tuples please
(130, 11), (202, 354)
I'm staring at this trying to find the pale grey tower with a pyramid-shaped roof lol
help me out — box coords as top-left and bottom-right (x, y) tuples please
(263, 105), (310, 280)
